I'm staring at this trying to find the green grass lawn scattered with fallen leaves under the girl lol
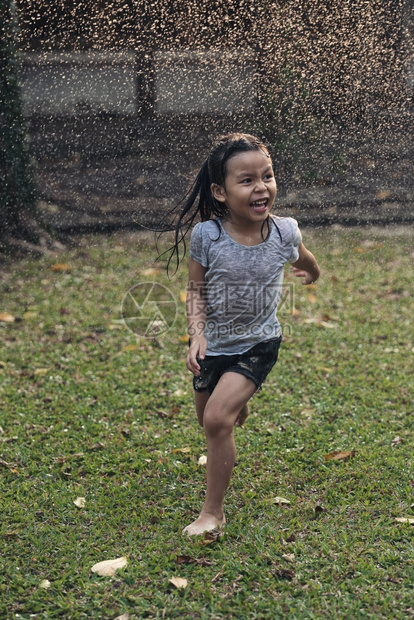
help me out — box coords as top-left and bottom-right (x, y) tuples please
(0, 229), (414, 619)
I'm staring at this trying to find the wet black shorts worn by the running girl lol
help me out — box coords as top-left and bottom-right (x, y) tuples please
(193, 336), (282, 394)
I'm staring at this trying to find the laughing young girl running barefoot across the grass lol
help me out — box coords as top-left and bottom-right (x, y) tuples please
(163, 134), (319, 536)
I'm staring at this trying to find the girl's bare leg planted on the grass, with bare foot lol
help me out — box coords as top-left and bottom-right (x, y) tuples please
(183, 372), (256, 536)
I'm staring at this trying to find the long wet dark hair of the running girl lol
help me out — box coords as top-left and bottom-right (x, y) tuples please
(158, 133), (270, 273)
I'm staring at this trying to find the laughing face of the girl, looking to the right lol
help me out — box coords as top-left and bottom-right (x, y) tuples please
(211, 150), (277, 226)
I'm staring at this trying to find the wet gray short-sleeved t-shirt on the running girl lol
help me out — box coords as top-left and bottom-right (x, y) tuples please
(190, 216), (302, 355)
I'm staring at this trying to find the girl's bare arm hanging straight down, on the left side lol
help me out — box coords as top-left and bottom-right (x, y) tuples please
(186, 258), (207, 375)
